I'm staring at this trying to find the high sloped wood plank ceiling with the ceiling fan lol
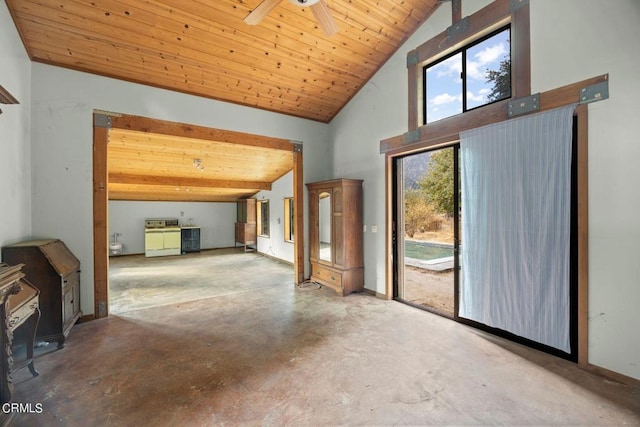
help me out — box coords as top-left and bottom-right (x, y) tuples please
(5, 0), (440, 123)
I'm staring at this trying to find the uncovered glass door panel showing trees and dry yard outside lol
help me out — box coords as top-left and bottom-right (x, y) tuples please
(394, 145), (460, 317)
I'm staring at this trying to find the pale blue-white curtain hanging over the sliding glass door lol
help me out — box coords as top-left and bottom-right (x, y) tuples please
(458, 105), (575, 353)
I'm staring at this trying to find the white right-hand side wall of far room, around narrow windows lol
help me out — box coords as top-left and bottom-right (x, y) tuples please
(256, 171), (294, 263)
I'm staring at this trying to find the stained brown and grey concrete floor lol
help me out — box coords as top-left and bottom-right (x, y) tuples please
(14, 251), (640, 426)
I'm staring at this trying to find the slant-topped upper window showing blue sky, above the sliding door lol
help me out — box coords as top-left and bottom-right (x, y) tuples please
(423, 26), (511, 124)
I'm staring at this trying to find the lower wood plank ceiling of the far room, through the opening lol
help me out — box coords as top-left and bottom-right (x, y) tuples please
(107, 128), (293, 202)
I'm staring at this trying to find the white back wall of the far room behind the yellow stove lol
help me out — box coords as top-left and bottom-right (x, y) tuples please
(109, 200), (236, 254)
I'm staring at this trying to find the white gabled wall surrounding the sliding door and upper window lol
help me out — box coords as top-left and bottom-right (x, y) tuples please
(331, 0), (640, 379)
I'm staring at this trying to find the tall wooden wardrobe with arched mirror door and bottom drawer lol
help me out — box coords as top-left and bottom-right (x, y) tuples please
(307, 179), (364, 296)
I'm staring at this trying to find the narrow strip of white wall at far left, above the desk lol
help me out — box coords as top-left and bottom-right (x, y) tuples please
(0, 2), (31, 246)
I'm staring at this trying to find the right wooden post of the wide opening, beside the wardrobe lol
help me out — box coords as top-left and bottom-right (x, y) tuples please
(293, 151), (305, 284)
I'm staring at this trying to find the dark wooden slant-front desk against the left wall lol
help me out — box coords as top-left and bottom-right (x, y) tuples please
(2, 239), (82, 348)
